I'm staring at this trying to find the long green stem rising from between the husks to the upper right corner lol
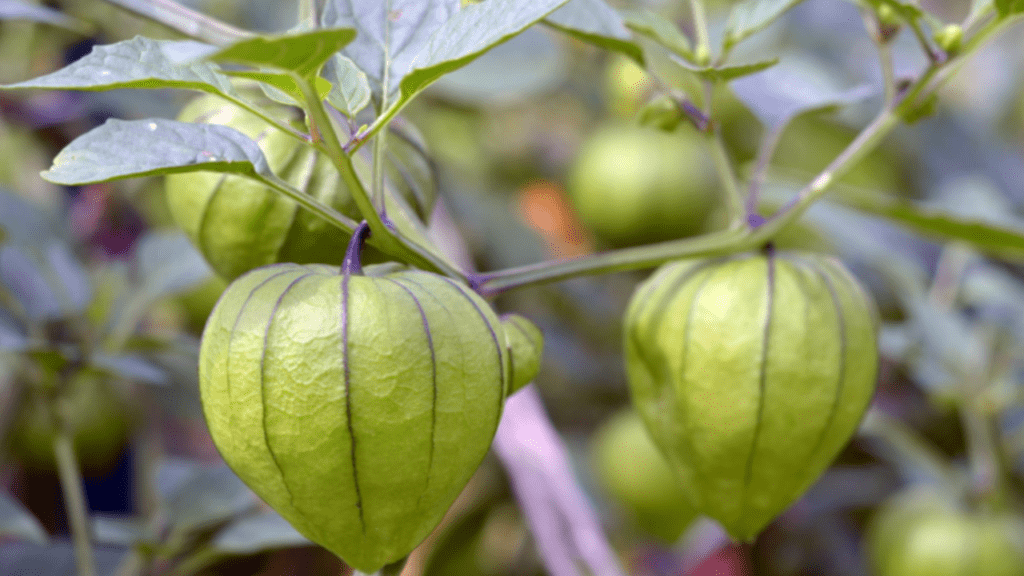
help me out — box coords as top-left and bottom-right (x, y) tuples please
(473, 18), (1019, 294)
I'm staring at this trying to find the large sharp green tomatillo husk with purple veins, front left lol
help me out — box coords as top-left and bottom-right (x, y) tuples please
(200, 263), (512, 573)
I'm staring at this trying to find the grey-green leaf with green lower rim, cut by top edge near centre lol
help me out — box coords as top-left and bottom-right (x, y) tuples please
(544, 0), (643, 64)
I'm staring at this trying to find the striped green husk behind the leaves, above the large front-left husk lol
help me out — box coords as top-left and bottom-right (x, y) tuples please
(167, 95), (436, 280)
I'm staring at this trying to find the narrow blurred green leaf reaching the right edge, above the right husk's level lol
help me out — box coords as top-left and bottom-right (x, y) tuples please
(829, 191), (1024, 261)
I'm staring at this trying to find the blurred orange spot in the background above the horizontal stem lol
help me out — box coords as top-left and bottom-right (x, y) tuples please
(519, 180), (593, 258)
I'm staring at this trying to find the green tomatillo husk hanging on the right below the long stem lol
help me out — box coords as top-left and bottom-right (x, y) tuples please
(625, 252), (879, 540)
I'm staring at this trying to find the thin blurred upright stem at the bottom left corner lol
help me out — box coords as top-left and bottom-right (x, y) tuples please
(53, 407), (96, 576)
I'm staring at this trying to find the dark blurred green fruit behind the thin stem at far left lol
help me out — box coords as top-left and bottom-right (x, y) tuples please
(8, 372), (131, 476)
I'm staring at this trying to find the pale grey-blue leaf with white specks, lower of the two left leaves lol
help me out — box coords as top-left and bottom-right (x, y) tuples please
(41, 118), (271, 186)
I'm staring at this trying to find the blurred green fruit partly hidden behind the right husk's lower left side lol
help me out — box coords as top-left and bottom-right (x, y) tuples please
(592, 410), (696, 542)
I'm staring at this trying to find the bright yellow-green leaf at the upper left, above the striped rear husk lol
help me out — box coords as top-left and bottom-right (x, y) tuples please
(199, 28), (355, 78)
